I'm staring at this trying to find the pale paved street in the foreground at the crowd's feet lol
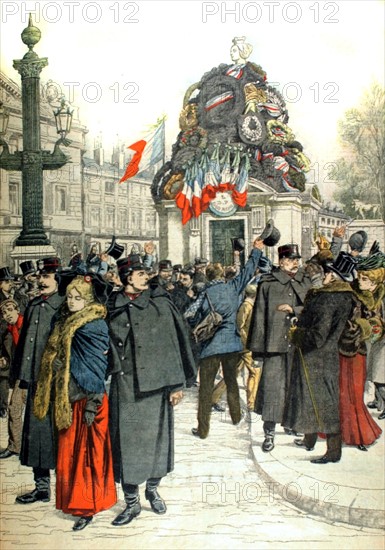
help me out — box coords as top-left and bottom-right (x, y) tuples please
(0, 388), (385, 550)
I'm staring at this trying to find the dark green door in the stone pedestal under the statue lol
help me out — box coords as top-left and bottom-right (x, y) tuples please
(210, 220), (245, 265)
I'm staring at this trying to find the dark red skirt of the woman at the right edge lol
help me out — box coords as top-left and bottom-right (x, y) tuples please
(340, 353), (382, 445)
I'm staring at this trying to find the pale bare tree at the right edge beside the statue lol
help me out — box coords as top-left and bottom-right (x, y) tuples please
(332, 83), (385, 221)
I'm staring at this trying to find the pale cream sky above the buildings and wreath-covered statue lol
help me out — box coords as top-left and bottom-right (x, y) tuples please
(0, 0), (385, 203)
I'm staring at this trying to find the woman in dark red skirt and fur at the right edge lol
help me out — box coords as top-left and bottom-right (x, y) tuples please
(340, 268), (385, 451)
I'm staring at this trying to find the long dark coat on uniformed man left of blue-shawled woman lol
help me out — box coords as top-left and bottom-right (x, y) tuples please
(14, 293), (64, 469)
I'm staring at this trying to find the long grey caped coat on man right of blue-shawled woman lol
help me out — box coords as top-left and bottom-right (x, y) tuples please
(107, 287), (196, 485)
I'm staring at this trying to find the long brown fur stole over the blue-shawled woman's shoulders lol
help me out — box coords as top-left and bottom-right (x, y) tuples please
(33, 303), (107, 430)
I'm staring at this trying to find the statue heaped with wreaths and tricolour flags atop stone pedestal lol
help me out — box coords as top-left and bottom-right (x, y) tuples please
(152, 37), (310, 223)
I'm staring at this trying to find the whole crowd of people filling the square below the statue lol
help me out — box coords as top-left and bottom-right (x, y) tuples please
(0, 227), (385, 530)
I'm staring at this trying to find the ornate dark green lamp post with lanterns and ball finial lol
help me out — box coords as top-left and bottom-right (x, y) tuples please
(0, 15), (72, 255)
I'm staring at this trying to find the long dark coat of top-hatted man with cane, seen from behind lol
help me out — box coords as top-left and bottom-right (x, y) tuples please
(284, 281), (354, 434)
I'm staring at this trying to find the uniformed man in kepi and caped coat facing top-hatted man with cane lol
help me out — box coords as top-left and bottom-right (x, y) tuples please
(247, 243), (311, 452)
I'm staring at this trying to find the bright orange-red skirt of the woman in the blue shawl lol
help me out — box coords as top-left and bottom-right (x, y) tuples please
(56, 394), (116, 516)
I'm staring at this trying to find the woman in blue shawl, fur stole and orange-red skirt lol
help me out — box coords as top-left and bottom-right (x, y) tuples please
(34, 273), (116, 531)
